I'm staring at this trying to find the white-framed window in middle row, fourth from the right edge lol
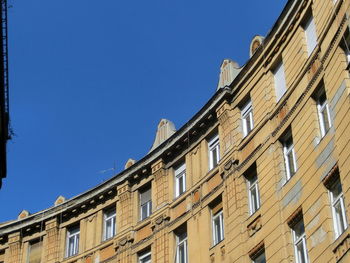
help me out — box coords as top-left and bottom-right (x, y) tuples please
(245, 165), (260, 215)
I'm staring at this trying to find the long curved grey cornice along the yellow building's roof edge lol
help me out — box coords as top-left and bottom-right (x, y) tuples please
(0, 0), (302, 235)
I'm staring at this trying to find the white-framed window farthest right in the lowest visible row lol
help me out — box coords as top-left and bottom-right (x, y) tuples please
(329, 177), (348, 238)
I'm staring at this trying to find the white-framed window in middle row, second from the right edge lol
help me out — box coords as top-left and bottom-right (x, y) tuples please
(316, 87), (332, 137)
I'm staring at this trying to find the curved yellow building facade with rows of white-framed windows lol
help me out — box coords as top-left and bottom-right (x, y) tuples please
(0, 0), (350, 263)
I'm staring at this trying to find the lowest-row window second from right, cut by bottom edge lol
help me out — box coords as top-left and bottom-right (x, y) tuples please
(292, 218), (309, 263)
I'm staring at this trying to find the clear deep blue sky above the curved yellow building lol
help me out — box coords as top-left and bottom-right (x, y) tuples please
(0, 0), (286, 222)
